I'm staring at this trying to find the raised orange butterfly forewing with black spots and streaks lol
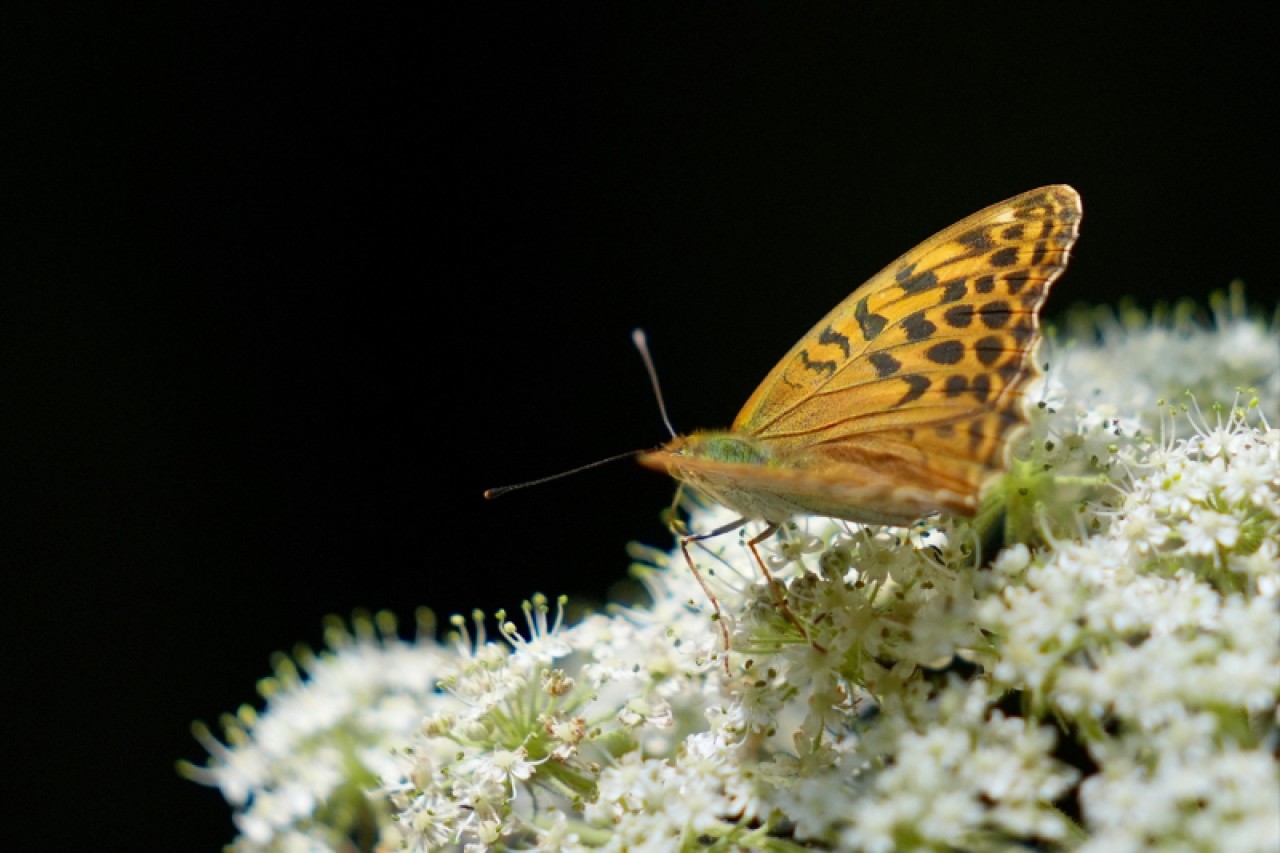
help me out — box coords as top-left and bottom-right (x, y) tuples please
(733, 186), (1080, 451)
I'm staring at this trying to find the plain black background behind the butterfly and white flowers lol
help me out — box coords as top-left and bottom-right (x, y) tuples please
(10, 3), (1280, 849)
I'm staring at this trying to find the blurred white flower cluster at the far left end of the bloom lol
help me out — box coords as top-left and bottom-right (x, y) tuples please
(179, 611), (452, 853)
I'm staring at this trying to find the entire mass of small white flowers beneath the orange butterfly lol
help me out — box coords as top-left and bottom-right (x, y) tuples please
(188, 295), (1280, 853)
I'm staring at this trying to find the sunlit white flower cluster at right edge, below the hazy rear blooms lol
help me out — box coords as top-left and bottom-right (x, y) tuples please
(978, 394), (1280, 850)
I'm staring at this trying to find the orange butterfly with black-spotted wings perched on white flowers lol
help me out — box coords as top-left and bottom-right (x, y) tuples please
(639, 184), (1082, 648)
